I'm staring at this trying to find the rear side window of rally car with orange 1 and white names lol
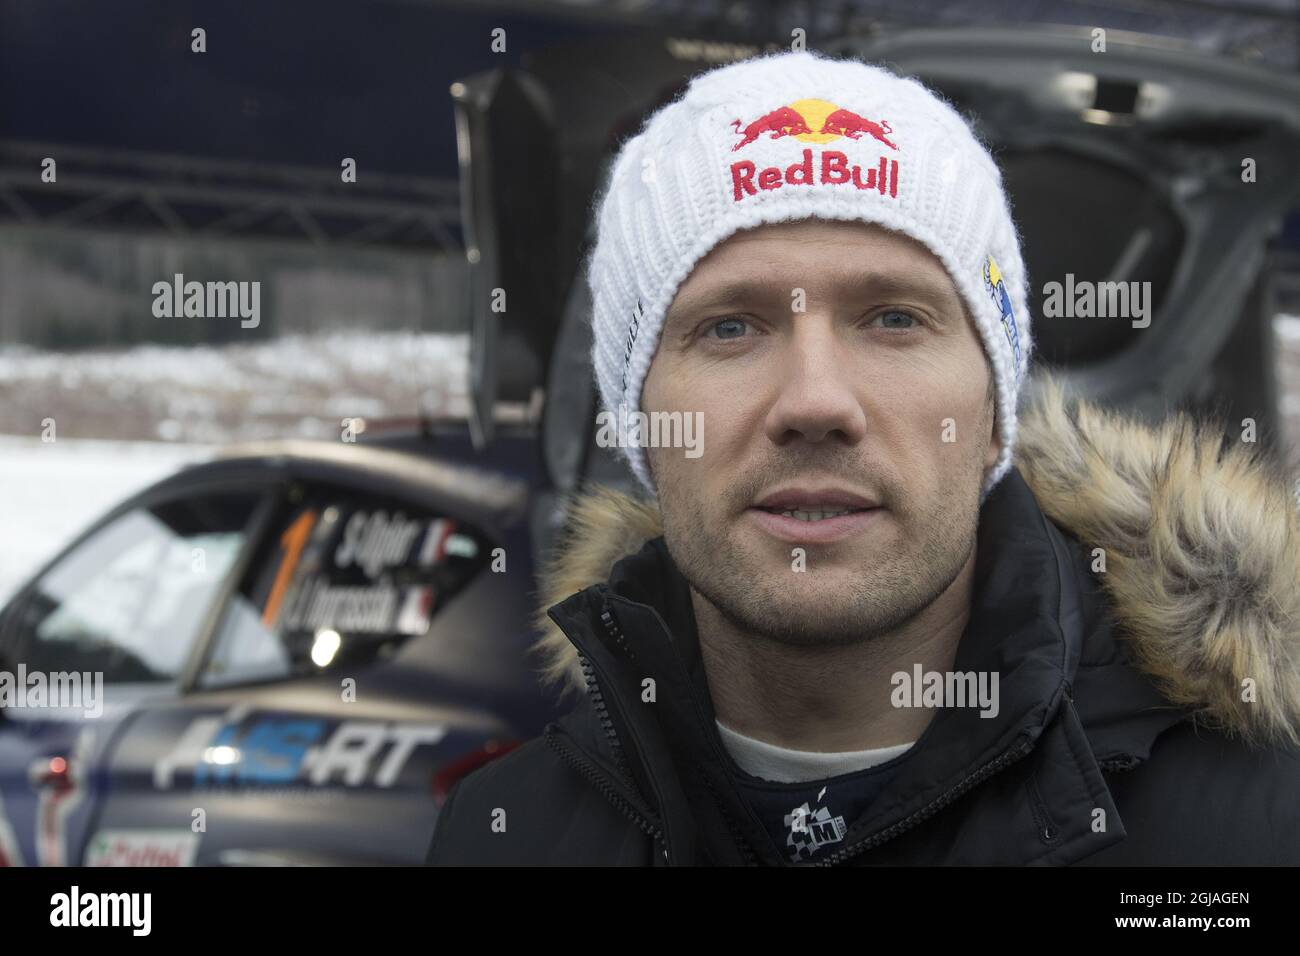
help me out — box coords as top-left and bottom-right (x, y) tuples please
(199, 488), (490, 688)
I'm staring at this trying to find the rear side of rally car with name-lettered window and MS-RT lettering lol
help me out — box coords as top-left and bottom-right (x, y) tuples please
(85, 481), (522, 865)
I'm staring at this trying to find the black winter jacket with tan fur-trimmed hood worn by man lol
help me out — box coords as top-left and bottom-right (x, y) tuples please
(429, 385), (1300, 865)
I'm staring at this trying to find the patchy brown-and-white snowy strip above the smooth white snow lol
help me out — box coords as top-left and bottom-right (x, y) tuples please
(0, 332), (469, 442)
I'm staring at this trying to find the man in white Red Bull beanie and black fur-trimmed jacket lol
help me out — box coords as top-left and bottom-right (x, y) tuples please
(429, 53), (1300, 865)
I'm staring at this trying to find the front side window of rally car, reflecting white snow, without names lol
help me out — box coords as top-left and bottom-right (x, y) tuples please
(12, 493), (259, 683)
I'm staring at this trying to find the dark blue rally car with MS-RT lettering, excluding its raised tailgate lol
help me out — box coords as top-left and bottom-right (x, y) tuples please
(0, 428), (569, 865)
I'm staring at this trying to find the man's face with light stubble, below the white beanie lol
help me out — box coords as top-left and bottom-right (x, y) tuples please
(641, 220), (998, 645)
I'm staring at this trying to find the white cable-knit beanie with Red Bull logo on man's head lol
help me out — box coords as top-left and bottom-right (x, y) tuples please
(588, 52), (1032, 501)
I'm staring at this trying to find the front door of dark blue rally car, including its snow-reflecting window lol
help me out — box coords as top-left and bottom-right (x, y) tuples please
(0, 483), (264, 865)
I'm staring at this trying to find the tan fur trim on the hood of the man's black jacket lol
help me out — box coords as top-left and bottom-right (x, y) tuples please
(537, 378), (1300, 744)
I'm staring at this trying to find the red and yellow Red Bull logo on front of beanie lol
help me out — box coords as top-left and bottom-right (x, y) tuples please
(731, 99), (898, 203)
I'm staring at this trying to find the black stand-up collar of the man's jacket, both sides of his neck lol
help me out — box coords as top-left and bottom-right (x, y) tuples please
(551, 471), (1118, 862)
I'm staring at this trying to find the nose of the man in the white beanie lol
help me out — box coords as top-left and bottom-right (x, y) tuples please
(764, 312), (867, 446)
